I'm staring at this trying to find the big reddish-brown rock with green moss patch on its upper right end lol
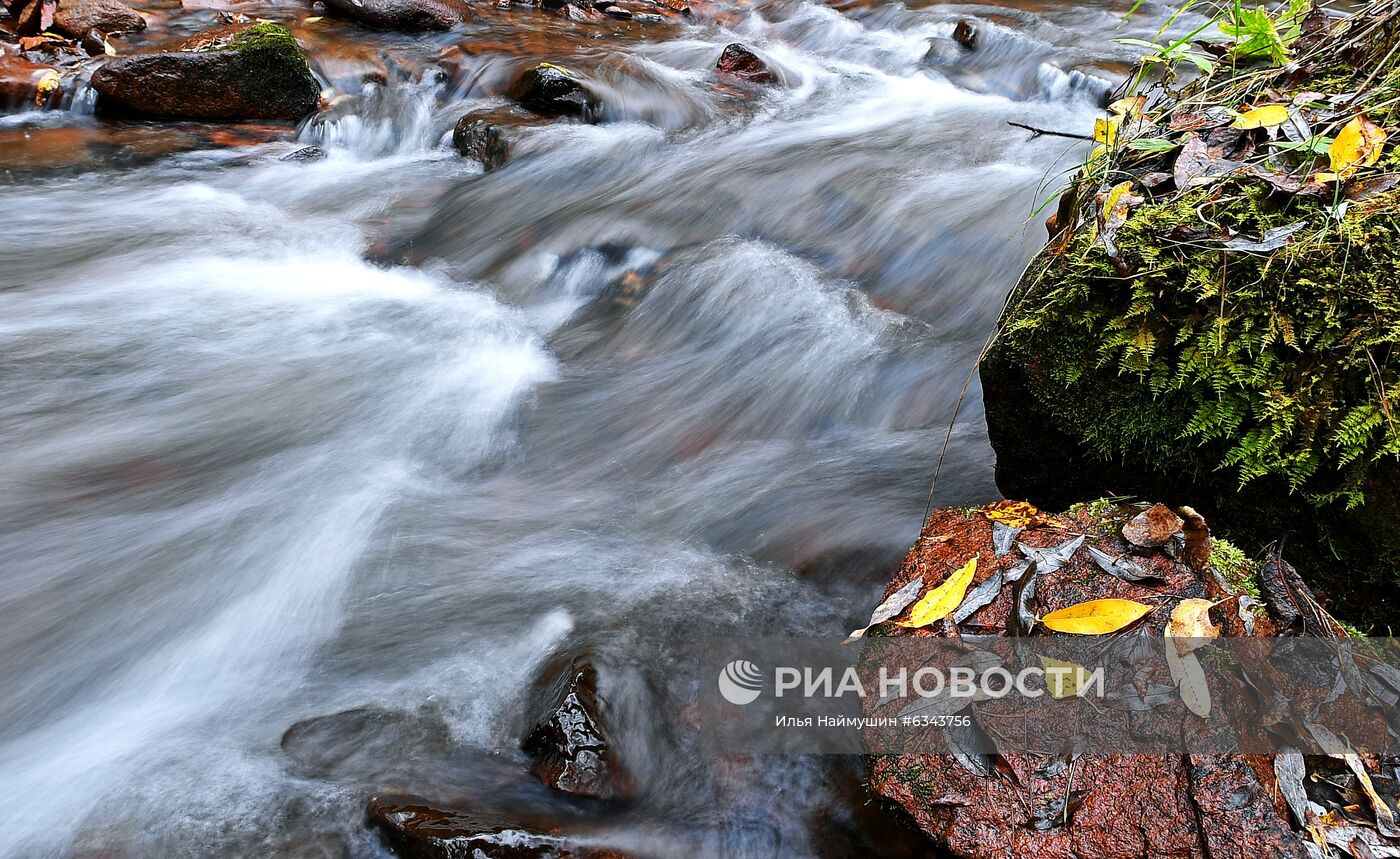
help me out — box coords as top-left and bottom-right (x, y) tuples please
(92, 24), (321, 120)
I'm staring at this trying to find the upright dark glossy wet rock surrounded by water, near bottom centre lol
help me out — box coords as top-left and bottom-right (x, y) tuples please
(521, 656), (629, 799)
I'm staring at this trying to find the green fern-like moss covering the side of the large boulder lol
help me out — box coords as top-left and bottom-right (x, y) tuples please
(1004, 185), (1400, 508)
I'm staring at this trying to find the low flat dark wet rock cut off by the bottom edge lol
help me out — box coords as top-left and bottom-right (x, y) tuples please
(365, 795), (626, 859)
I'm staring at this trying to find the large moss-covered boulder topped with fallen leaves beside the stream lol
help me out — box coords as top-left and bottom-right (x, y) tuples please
(981, 0), (1400, 631)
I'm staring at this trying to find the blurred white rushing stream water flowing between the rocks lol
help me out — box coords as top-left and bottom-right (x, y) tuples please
(0, 0), (1192, 859)
